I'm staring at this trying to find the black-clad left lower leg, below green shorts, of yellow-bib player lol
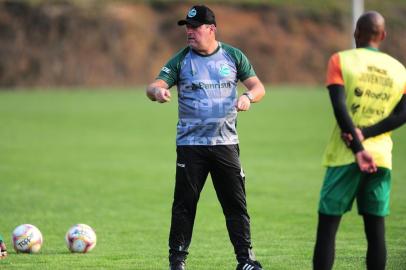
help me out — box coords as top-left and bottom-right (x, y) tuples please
(313, 213), (341, 270)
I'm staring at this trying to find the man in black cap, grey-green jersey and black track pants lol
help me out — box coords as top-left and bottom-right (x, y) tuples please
(146, 5), (265, 270)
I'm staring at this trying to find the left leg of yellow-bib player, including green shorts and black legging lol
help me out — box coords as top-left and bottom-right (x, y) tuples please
(313, 163), (361, 270)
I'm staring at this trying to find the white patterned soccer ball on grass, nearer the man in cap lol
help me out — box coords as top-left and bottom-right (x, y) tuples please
(65, 224), (96, 253)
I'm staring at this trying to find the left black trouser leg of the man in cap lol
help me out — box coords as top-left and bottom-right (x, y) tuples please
(169, 146), (209, 269)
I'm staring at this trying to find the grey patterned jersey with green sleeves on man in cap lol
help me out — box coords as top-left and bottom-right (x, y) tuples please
(157, 42), (256, 145)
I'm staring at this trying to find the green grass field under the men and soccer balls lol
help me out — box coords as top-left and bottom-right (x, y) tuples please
(0, 87), (406, 270)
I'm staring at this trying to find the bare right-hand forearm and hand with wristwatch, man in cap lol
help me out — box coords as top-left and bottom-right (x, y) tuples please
(236, 76), (265, 111)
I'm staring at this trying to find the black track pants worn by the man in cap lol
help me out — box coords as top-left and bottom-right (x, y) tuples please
(169, 145), (251, 261)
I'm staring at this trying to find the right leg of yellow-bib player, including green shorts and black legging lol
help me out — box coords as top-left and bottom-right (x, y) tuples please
(357, 168), (391, 270)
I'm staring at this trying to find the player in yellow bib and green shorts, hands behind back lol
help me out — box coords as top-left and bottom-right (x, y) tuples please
(313, 11), (406, 270)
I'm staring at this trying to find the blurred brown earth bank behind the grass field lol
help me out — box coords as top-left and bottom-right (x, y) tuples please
(0, 0), (406, 89)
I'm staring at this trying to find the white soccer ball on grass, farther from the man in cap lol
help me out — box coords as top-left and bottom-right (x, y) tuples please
(13, 224), (42, 253)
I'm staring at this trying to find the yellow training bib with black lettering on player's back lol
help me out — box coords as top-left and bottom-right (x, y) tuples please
(323, 48), (406, 169)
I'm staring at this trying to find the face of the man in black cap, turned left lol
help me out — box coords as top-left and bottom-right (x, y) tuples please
(186, 24), (215, 51)
